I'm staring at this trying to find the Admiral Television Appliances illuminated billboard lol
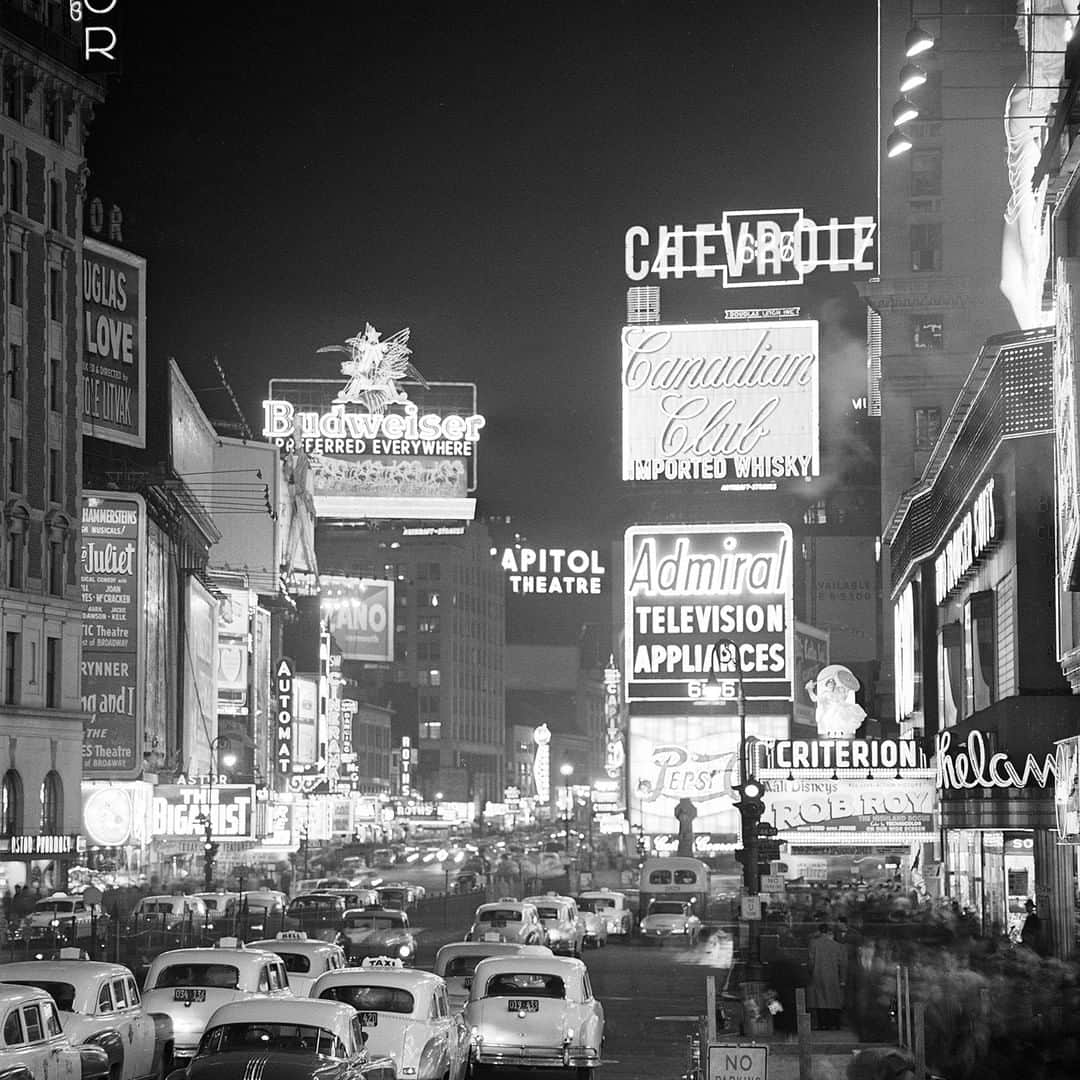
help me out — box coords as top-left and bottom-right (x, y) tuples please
(623, 523), (795, 702)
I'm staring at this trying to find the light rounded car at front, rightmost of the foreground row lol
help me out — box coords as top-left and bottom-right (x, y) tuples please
(464, 955), (604, 1080)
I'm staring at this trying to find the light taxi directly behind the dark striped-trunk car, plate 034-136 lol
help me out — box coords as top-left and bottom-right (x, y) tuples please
(143, 937), (294, 1058)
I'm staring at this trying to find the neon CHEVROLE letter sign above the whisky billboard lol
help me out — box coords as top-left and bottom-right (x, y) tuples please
(624, 208), (877, 288)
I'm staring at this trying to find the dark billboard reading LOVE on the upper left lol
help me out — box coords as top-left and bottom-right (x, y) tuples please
(81, 239), (146, 447)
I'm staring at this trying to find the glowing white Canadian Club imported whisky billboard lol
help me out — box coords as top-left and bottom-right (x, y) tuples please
(622, 320), (821, 490)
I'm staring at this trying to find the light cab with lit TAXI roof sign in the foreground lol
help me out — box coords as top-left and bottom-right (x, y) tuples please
(311, 957), (469, 1080)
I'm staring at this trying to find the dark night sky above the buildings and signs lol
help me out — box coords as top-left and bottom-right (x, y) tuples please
(89, 0), (876, 537)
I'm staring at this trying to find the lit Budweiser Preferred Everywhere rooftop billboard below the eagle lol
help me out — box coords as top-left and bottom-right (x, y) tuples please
(262, 379), (485, 521)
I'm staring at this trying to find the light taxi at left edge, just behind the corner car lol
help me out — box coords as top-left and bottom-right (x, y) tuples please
(0, 963), (173, 1080)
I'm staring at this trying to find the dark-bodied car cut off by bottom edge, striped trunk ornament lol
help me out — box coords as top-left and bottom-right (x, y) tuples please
(168, 998), (395, 1080)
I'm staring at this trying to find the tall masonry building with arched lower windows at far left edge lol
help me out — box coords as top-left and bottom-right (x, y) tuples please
(0, 3), (105, 891)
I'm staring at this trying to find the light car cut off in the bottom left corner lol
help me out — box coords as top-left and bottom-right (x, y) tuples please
(0, 986), (109, 1080)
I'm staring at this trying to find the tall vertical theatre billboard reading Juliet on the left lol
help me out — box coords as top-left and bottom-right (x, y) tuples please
(80, 491), (146, 780)
